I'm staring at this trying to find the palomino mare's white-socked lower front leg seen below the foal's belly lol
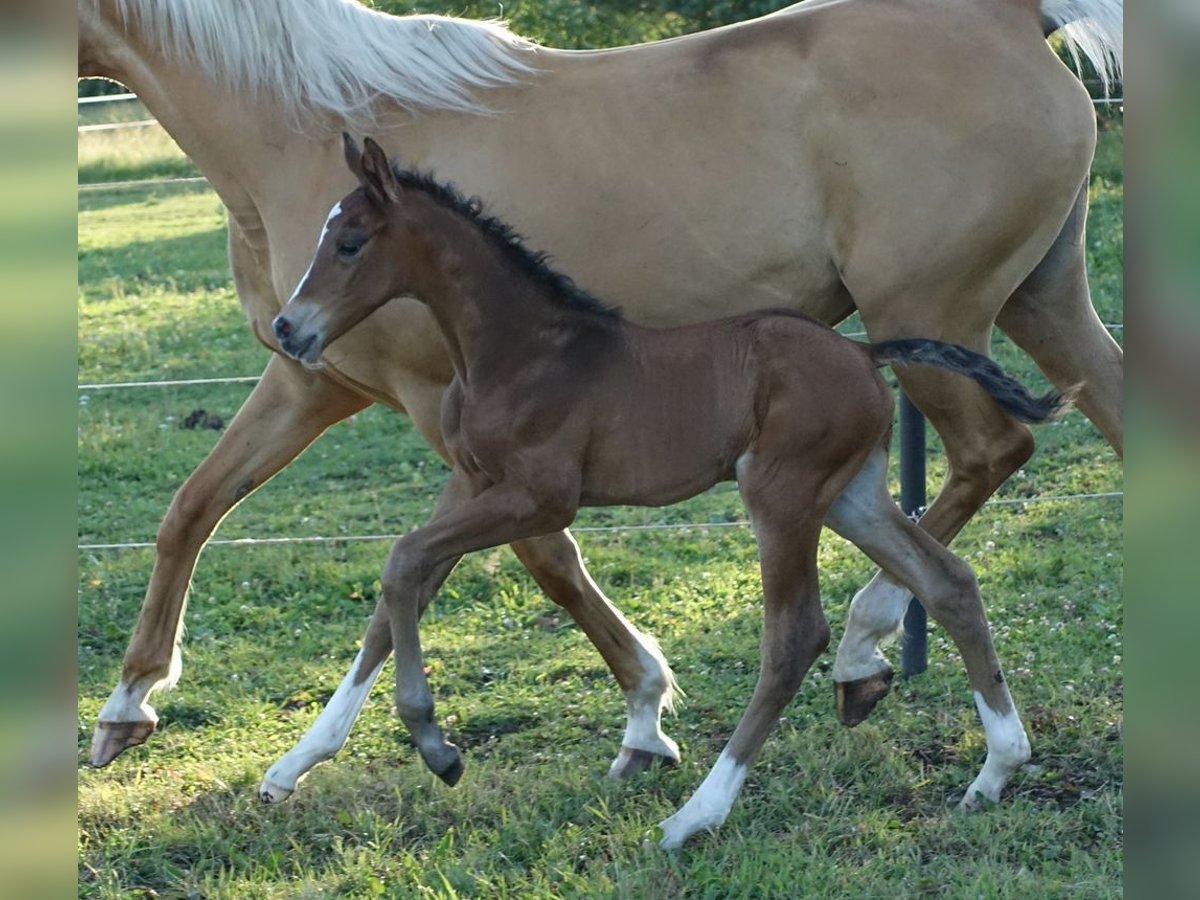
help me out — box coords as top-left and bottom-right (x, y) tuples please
(512, 532), (679, 778)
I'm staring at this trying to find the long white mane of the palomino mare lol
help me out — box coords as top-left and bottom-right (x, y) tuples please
(108, 0), (536, 125)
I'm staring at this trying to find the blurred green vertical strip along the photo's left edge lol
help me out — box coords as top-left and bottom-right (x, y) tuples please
(0, 0), (76, 898)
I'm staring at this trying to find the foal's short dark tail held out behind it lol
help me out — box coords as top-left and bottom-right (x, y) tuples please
(868, 337), (1081, 425)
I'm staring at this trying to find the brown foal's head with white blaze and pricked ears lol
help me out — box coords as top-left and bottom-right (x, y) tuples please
(274, 134), (416, 365)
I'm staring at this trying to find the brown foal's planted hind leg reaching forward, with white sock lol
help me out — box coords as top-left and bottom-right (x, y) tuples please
(660, 466), (829, 848)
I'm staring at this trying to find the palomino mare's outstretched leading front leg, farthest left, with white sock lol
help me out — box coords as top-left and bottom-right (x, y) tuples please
(91, 356), (371, 766)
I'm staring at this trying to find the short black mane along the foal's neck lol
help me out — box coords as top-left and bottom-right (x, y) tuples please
(392, 164), (620, 318)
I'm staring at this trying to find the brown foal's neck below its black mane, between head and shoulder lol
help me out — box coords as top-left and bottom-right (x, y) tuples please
(406, 196), (614, 383)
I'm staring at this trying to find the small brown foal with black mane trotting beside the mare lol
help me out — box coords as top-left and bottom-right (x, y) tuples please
(268, 138), (1066, 847)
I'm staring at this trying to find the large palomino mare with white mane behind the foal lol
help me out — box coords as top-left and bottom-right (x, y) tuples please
(78, 0), (1122, 791)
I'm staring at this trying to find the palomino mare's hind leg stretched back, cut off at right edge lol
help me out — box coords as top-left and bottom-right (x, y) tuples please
(996, 184), (1123, 454)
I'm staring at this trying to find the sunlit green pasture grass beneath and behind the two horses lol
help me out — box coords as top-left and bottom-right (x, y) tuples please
(78, 125), (1122, 898)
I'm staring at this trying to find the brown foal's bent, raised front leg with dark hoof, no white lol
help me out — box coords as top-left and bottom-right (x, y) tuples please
(382, 469), (577, 785)
